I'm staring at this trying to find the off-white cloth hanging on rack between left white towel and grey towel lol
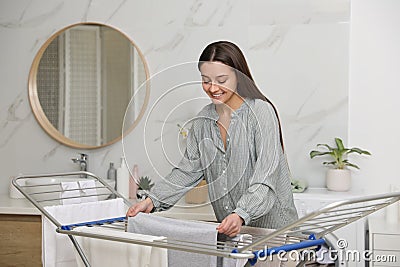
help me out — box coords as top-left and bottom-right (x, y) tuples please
(75, 227), (168, 267)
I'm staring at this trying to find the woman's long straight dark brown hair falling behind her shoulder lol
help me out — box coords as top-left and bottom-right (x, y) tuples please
(198, 41), (284, 149)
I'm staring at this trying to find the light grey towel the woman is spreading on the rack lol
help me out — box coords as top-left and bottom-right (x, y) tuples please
(127, 213), (217, 267)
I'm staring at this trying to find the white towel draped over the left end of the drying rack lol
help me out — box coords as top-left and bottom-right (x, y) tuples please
(42, 198), (126, 267)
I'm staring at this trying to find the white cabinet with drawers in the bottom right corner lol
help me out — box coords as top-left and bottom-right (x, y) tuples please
(368, 218), (400, 267)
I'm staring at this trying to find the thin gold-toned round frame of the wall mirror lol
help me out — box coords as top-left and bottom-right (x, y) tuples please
(28, 22), (150, 149)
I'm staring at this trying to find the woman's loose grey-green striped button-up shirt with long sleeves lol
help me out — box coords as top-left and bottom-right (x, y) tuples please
(149, 99), (297, 229)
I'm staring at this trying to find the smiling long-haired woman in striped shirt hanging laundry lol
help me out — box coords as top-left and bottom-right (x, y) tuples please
(127, 41), (297, 237)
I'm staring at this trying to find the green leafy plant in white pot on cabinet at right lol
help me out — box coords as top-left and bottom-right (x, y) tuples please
(310, 138), (371, 191)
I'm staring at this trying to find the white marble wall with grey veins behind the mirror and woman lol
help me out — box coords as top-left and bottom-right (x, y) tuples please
(0, 0), (350, 193)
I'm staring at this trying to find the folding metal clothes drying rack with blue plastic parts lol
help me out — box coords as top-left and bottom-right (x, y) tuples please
(12, 172), (400, 266)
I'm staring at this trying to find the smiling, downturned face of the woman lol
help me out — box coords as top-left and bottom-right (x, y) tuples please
(200, 62), (237, 105)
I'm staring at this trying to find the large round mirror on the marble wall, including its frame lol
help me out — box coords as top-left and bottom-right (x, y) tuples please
(29, 23), (149, 149)
